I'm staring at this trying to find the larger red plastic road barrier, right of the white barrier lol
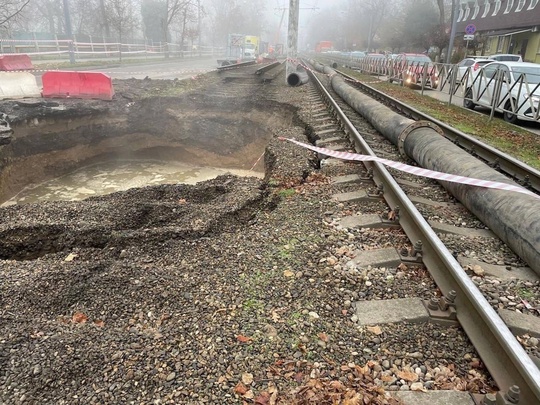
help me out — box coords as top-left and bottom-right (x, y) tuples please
(42, 71), (114, 100)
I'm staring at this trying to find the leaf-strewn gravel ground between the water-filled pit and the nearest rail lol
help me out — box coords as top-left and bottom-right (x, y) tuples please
(0, 74), (498, 405)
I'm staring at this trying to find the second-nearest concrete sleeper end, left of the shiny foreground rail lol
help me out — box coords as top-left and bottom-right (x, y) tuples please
(354, 298), (429, 325)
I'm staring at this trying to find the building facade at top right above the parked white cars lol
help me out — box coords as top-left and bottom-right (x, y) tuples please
(456, 0), (540, 63)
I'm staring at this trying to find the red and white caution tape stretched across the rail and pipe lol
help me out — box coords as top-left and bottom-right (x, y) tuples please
(279, 137), (540, 199)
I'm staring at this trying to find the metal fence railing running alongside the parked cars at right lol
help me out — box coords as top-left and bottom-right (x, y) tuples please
(316, 53), (540, 122)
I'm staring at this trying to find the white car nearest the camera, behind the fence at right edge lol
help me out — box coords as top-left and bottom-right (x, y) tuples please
(463, 62), (540, 123)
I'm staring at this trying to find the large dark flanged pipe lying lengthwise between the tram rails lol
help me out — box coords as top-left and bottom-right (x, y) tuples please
(312, 63), (540, 275)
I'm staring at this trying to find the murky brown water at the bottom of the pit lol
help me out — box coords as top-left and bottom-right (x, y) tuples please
(0, 161), (264, 207)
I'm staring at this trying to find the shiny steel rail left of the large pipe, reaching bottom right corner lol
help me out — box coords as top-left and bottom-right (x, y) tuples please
(309, 65), (540, 404)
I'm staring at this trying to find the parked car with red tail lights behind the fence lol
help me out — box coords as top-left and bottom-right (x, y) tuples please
(388, 53), (439, 88)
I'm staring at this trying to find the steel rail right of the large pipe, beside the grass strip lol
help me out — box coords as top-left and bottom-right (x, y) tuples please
(336, 70), (540, 193)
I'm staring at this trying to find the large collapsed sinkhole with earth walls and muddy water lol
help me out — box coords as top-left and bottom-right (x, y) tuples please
(0, 93), (295, 206)
